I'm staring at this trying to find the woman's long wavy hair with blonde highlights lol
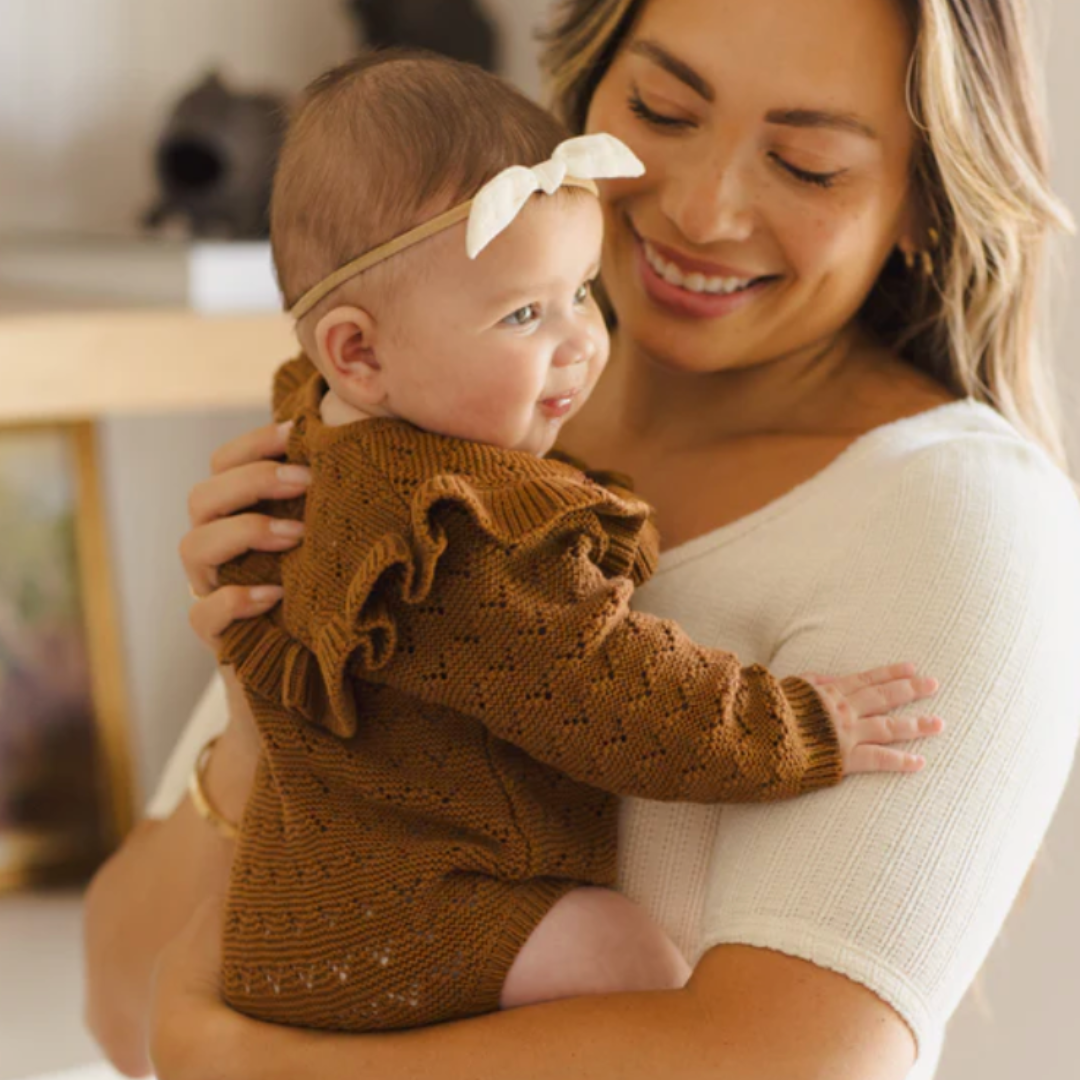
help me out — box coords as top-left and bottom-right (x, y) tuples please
(544, 0), (1072, 467)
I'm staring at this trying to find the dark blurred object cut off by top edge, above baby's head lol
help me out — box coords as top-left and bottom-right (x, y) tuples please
(349, 0), (498, 71)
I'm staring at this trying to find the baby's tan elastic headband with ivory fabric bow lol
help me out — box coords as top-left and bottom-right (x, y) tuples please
(289, 134), (645, 321)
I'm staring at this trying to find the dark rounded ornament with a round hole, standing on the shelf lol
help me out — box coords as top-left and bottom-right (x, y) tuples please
(144, 73), (286, 240)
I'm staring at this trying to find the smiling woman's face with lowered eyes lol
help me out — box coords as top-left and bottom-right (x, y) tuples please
(588, 0), (916, 373)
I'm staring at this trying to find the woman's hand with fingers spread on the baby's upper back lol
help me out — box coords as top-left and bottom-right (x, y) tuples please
(180, 423), (311, 652)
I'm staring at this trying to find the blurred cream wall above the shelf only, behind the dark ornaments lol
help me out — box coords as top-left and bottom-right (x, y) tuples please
(0, 0), (544, 235)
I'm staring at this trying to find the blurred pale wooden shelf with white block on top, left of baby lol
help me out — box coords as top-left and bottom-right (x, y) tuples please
(0, 235), (297, 423)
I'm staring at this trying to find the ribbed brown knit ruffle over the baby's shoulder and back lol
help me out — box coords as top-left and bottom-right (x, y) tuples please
(222, 421), (654, 739)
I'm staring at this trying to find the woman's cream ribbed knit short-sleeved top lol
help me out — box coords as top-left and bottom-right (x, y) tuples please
(149, 401), (1080, 1080)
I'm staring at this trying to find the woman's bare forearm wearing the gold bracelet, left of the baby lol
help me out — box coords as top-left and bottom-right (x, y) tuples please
(84, 733), (251, 1076)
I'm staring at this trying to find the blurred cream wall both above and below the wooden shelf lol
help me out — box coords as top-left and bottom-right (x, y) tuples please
(0, 0), (557, 789)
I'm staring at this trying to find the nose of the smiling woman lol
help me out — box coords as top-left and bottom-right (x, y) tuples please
(660, 160), (754, 245)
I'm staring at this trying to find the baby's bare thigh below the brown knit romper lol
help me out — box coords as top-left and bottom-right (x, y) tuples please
(499, 887), (690, 1009)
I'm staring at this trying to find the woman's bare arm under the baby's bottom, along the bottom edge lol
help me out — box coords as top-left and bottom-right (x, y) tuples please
(174, 946), (914, 1080)
